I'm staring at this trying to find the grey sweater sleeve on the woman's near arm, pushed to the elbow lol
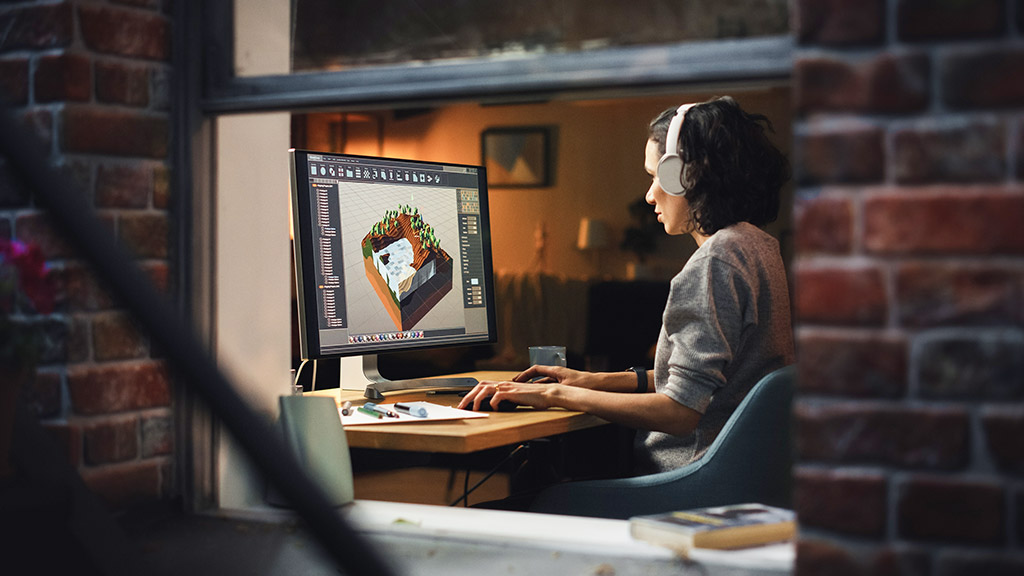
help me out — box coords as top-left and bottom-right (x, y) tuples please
(659, 255), (749, 414)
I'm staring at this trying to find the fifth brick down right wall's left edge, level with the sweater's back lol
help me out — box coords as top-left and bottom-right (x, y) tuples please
(795, 262), (888, 326)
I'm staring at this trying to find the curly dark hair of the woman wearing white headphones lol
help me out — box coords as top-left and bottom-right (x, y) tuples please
(647, 96), (790, 235)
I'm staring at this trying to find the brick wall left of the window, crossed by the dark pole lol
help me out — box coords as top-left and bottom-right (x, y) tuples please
(0, 0), (173, 507)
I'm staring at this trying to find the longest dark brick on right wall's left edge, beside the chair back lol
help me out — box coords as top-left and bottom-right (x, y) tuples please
(795, 402), (970, 469)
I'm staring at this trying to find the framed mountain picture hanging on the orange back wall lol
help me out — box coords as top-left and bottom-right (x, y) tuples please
(480, 126), (551, 188)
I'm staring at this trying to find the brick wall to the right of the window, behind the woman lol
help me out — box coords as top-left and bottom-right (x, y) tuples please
(791, 0), (1024, 576)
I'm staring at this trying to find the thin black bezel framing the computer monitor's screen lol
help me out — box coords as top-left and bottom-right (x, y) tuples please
(289, 149), (498, 360)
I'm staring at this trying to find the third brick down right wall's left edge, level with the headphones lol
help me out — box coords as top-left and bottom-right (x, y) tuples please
(796, 123), (885, 184)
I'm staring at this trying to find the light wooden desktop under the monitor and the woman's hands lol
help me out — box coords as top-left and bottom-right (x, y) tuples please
(309, 372), (607, 454)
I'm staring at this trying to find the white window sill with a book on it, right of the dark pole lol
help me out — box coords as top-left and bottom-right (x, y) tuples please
(340, 500), (796, 576)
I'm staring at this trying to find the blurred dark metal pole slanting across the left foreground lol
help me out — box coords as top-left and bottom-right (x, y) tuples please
(0, 105), (393, 576)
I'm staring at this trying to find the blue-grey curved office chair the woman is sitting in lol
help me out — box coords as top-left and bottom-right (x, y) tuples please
(529, 366), (796, 519)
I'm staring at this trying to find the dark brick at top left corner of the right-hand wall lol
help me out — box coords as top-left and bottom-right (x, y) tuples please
(791, 0), (886, 46)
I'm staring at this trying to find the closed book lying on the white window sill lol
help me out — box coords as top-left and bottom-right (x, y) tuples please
(630, 503), (797, 552)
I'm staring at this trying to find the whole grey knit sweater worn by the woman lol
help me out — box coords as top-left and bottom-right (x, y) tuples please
(636, 222), (794, 474)
